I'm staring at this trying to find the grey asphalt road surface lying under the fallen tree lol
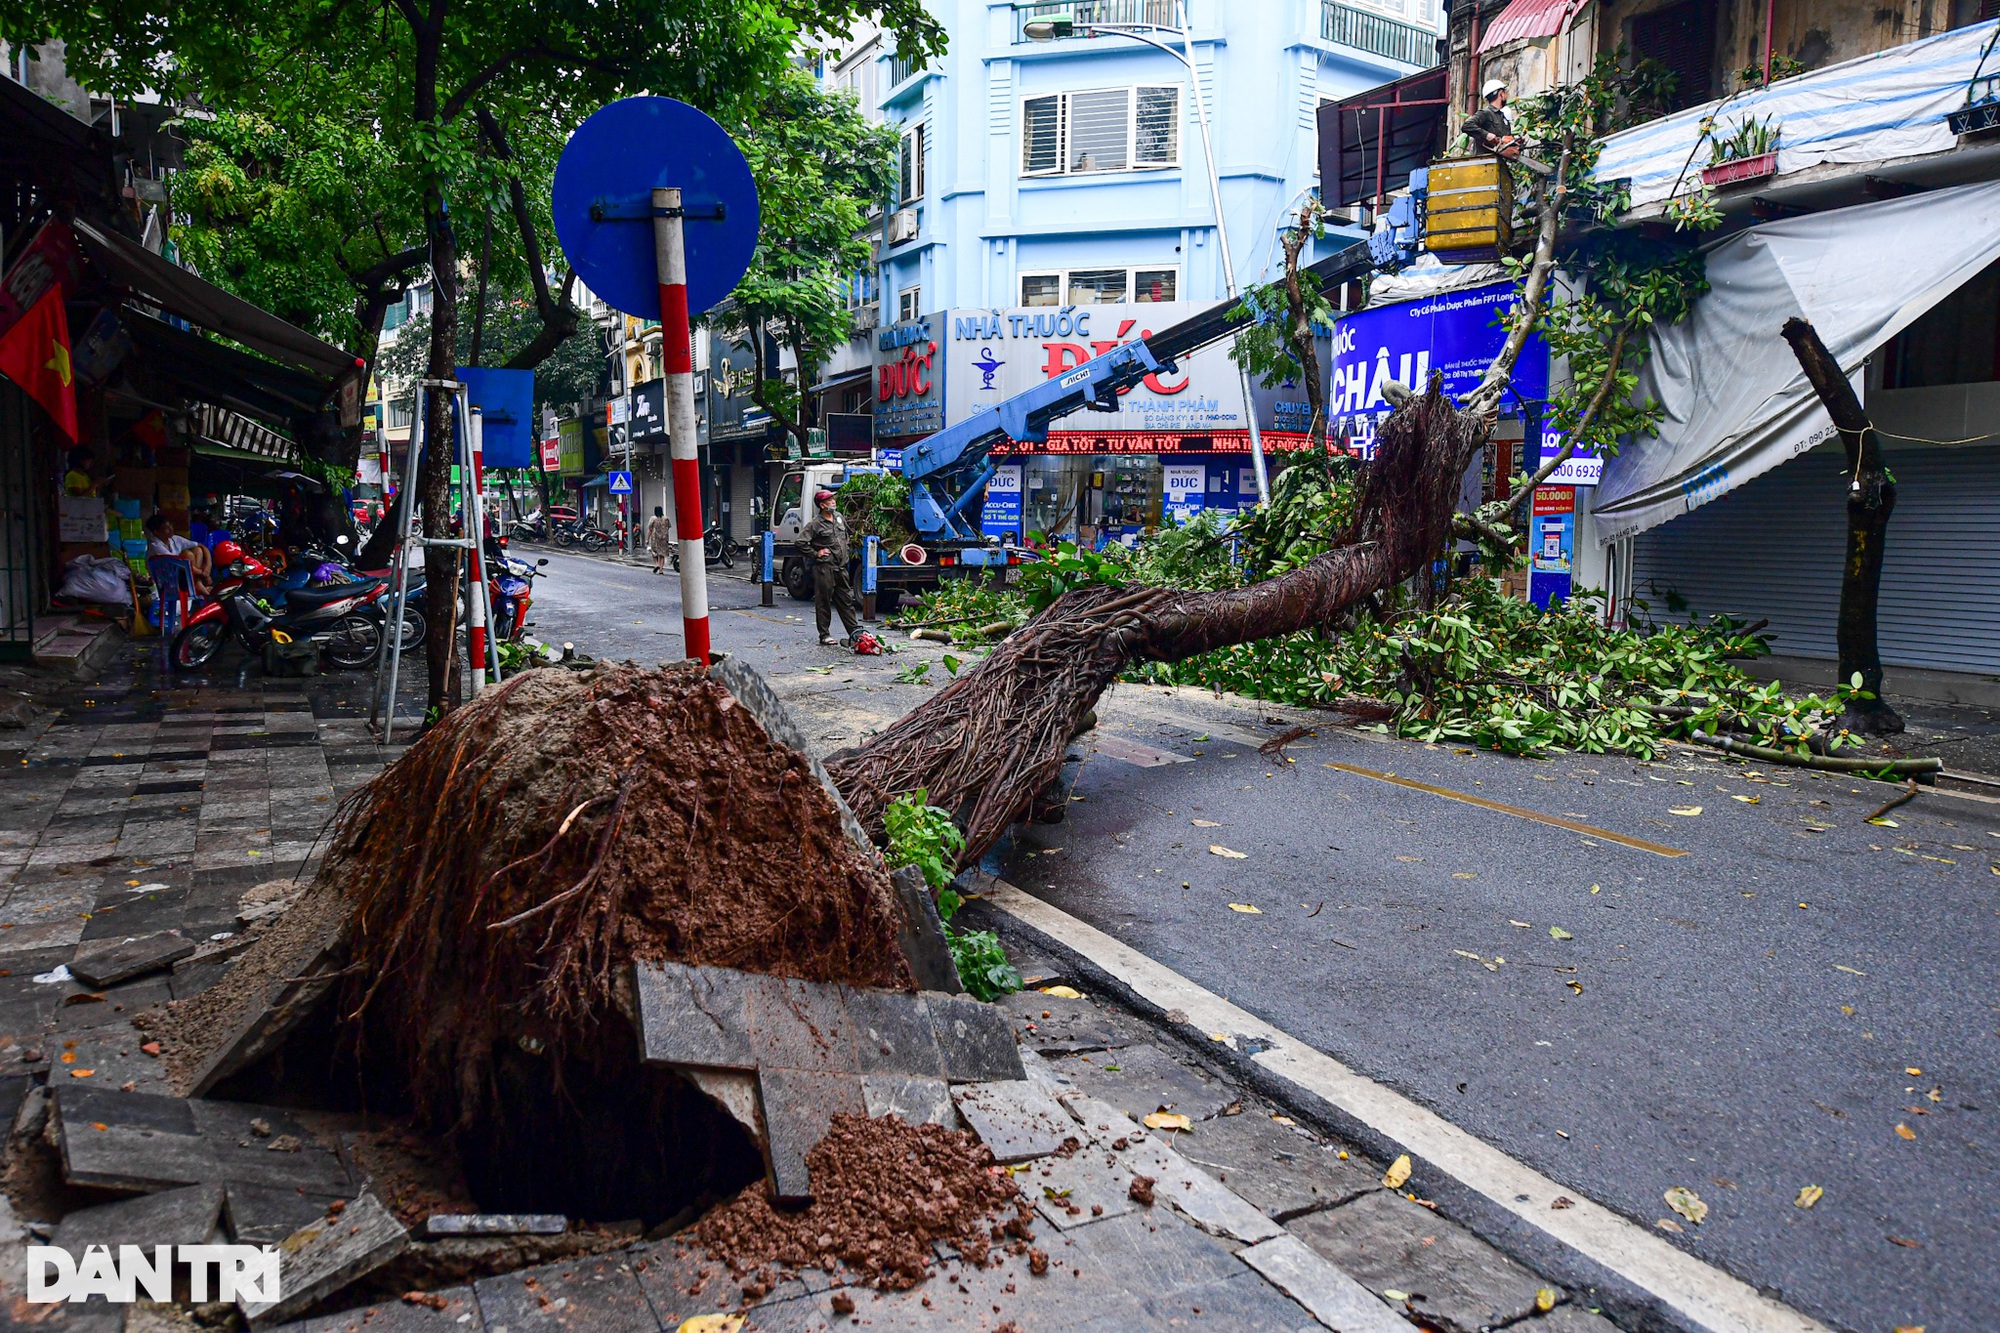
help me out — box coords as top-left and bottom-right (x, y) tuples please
(534, 540), (2000, 1333)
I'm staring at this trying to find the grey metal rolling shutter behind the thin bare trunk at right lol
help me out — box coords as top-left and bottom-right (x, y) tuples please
(1632, 446), (2000, 675)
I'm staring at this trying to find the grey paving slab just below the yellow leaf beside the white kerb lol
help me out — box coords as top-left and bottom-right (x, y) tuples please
(1288, 1191), (1542, 1333)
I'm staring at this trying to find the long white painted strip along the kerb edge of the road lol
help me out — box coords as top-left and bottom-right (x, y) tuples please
(976, 875), (1828, 1333)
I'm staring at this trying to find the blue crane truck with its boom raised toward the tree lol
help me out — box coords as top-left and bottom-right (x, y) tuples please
(772, 196), (1426, 604)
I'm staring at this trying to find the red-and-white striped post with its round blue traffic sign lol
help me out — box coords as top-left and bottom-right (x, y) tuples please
(552, 96), (758, 662)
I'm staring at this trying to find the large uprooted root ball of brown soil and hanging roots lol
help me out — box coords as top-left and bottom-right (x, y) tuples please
(320, 662), (914, 1125)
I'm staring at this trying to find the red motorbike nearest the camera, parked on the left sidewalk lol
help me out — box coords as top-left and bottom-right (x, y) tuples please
(168, 556), (390, 671)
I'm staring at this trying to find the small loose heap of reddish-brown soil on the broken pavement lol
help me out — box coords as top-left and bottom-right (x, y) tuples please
(686, 1115), (1034, 1291)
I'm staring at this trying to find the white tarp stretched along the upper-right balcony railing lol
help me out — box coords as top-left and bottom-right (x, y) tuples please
(1596, 20), (2000, 208)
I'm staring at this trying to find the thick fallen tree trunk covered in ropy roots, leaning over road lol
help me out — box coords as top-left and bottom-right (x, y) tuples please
(826, 376), (1486, 865)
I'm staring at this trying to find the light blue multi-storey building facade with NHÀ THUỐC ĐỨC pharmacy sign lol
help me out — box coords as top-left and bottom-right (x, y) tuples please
(868, 0), (1438, 536)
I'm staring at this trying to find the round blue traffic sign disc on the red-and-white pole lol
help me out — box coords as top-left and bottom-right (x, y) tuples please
(552, 98), (758, 320)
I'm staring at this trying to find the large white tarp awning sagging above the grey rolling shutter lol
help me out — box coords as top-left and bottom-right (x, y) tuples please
(1592, 182), (2000, 544)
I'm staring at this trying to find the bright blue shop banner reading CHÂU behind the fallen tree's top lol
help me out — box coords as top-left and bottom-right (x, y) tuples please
(1326, 282), (1548, 456)
